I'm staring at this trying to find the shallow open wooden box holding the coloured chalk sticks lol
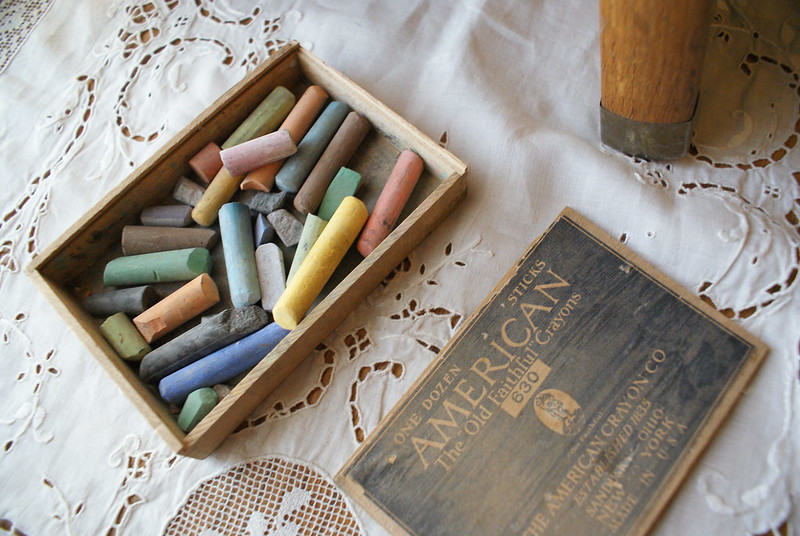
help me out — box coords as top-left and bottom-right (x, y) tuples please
(27, 43), (467, 458)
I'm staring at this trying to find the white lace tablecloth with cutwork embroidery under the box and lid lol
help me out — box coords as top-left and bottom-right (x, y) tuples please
(0, 0), (800, 536)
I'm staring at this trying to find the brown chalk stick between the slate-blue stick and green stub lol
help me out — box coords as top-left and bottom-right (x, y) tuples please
(294, 112), (371, 219)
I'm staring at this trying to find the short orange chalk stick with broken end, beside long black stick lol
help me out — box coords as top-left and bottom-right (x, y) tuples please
(133, 274), (219, 342)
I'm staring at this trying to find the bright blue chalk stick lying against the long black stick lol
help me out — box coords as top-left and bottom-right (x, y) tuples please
(158, 322), (289, 405)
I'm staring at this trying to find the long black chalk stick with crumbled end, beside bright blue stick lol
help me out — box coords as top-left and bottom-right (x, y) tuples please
(139, 305), (269, 383)
